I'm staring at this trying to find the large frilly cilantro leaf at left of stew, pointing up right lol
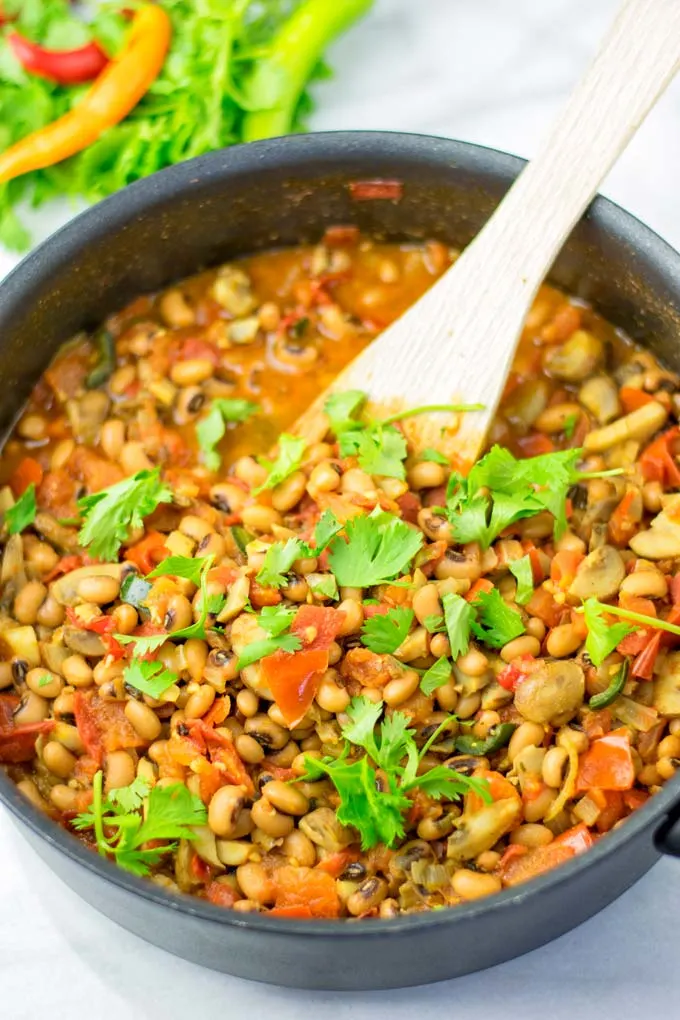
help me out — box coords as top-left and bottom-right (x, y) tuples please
(77, 467), (172, 560)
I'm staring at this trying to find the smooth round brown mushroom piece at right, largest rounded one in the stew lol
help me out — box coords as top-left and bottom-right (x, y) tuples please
(515, 659), (585, 726)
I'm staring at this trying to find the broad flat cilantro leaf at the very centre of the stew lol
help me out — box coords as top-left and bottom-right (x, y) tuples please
(328, 508), (423, 588)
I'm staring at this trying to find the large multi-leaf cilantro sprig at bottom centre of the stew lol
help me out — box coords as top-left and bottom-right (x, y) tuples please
(302, 698), (490, 850)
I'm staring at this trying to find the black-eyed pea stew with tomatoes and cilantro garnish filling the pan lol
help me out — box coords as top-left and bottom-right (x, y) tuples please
(0, 226), (680, 919)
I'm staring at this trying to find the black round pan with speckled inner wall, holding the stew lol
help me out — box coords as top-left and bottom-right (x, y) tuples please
(0, 133), (680, 988)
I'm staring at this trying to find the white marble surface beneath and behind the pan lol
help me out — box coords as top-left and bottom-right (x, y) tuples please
(0, 0), (680, 1020)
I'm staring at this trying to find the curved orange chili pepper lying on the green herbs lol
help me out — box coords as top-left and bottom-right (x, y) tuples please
(0, 4), (171, 182)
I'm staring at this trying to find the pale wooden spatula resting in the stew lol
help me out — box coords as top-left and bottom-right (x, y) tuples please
(294, 0), (680, 461)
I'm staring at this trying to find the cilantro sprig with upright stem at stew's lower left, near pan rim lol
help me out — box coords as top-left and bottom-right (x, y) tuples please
(72, 772), (207, 875)
